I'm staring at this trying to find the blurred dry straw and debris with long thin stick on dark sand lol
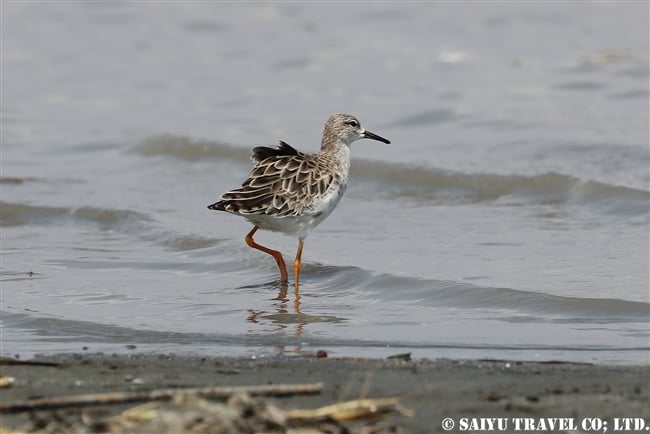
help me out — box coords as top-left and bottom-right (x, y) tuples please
(0, 383), (413, 434)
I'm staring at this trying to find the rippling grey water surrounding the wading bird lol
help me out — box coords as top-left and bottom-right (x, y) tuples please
(0, 2), (650, 363)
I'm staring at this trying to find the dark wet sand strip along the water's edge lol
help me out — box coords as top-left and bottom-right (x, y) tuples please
(0, 354), (650, 433)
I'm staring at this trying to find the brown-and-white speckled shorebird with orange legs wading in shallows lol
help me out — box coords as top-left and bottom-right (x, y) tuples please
(208, 113), (390, 288)
